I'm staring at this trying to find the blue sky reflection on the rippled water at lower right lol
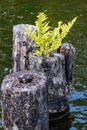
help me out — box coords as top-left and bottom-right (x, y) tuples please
(70, 90), (87, 130)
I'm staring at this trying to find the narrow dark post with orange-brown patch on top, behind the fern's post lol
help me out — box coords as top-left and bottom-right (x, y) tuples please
(60, 43), (76, 93)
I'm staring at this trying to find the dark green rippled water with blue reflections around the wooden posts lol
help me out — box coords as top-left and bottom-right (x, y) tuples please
(0, 0), (87, 130)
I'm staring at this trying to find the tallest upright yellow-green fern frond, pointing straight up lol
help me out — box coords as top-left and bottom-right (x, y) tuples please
(30, 13), (50, 56)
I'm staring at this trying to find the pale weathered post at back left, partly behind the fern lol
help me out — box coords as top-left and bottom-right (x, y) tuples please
(13, 24), (36, 72)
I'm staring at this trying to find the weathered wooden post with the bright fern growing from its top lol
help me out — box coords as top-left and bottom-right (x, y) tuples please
(29, 53), (69, 120)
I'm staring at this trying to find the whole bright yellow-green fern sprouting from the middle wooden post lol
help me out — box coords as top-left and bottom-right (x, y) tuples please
(25, 12), (77, 57)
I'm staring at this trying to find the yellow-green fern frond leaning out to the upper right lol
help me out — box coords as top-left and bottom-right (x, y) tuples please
(52, 17), (77, 50)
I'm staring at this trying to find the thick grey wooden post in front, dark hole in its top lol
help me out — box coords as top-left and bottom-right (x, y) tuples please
(2, 71), (49, 130)
